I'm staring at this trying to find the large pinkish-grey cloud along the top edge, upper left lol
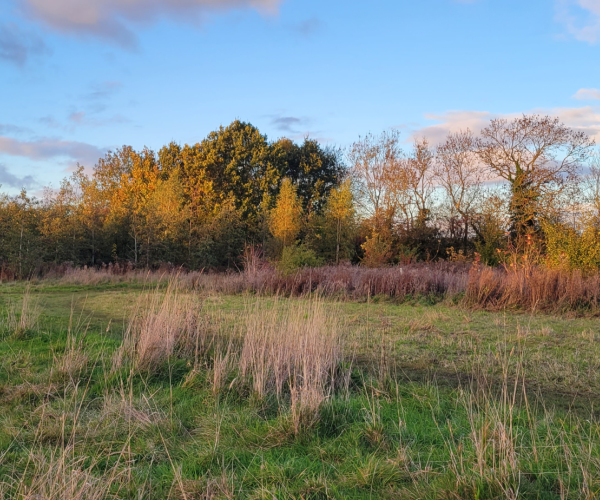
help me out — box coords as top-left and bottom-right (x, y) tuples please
(17, 0), (282, 46)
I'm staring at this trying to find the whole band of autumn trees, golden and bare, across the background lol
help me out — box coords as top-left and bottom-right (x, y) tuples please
(0, 115), (600, 279)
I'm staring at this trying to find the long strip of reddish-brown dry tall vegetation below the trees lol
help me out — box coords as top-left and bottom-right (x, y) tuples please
(38, 257), (600, 314)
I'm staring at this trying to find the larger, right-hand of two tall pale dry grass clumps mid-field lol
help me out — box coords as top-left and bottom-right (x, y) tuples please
(240, 299), (347, 434)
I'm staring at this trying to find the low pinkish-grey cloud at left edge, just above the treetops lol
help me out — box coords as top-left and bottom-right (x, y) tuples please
(0, 136), (106, 165)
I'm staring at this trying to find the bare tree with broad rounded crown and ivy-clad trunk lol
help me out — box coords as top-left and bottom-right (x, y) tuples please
(477, 115), (594, 235)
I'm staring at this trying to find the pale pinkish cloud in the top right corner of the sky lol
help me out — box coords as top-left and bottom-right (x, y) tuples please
(556, 0), (600, 44)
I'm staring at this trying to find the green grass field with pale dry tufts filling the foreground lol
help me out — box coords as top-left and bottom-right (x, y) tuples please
(0, 280), (600, 500)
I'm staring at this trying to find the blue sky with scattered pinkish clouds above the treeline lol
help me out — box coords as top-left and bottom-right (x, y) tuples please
(0, 0), (600, 194)
